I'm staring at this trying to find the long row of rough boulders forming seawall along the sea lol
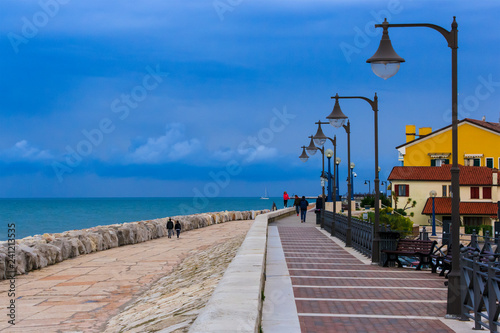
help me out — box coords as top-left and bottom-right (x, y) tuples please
(0, 210), (269, 279)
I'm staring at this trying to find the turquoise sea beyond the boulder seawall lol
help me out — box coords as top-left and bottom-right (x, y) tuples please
(0, 197), (283, 241)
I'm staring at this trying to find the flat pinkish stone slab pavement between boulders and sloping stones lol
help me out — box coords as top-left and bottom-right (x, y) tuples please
(0, 221), (253, 332)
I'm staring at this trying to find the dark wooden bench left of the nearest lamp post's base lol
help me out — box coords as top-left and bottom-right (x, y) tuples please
(382, 239), (436, 270)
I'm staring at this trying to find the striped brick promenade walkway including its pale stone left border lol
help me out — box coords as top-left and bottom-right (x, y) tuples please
(262, 212), (473, 333)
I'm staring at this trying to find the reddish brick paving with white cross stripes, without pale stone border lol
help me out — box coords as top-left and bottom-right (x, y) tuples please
(278, 224), (460, 333)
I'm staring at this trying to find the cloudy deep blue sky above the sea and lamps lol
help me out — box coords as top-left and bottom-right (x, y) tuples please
(0, 0), (500, 198)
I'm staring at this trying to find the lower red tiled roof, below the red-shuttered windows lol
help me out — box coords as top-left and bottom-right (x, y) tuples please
(422, 198), (498, 216)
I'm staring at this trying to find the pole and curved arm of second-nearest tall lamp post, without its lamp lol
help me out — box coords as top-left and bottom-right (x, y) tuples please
(332, 92), (380, 263)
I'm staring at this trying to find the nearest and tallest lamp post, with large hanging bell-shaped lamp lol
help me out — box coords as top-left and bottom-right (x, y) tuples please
(366, 16), (461, 318)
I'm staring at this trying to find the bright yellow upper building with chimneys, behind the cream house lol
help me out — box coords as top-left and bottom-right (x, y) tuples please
(396, 118), (500, 169)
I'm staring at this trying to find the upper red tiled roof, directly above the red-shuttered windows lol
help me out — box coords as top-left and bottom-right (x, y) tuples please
(387, 164), (498, 185)
